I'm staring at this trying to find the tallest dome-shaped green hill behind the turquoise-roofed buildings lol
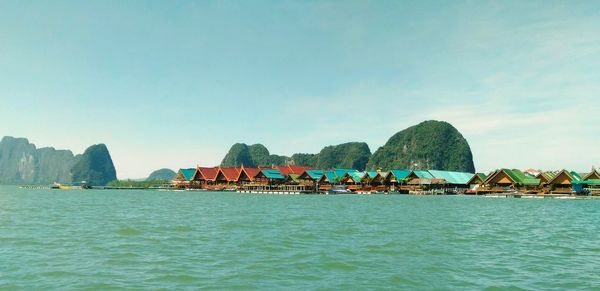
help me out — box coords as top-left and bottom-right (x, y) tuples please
(367, 121), (475, 173)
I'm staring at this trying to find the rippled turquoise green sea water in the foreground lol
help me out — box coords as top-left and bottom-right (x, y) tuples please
(0, 187), (600, 290)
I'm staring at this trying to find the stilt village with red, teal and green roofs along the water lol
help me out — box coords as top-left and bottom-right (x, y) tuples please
(169, 165), (600, 198)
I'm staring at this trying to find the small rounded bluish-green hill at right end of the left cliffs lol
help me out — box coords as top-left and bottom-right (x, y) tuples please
(71, 144), (117, 186)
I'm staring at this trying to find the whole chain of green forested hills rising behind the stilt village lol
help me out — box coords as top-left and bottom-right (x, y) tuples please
(221, 120), (475, 173)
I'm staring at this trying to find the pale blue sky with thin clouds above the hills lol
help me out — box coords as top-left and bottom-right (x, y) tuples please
(0, 0), (600, 178)
